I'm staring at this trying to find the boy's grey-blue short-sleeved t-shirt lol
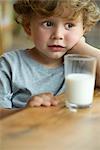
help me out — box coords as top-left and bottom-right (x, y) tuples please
(0, 50), (64, 108)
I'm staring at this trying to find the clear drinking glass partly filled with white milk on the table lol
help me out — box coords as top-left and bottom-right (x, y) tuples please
(64, 54), (96, 109)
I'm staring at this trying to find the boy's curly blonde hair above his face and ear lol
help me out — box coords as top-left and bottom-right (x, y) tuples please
(13, 0), (100, 32)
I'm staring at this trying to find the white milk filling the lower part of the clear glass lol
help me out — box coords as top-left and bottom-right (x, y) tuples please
(65, 73), (95, 106)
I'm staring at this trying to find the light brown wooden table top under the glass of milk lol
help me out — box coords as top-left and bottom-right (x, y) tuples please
(0, 89), (100, 150)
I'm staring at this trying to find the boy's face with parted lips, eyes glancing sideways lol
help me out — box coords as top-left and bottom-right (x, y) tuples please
(25, 9), (83, 59)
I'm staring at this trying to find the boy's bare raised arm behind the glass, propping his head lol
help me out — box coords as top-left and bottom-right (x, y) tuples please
(69, 40), (100, 87)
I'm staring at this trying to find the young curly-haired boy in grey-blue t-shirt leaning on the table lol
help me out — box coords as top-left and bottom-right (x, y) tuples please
(0, 0), (100, 108)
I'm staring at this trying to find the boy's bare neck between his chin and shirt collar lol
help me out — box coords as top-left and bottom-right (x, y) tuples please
(28, 48), (63, 68)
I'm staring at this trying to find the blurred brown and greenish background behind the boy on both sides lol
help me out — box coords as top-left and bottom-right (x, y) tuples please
(0, 0), (100, 54)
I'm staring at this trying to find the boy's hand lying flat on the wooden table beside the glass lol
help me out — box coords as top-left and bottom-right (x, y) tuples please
(26, 93), (58, 107)
